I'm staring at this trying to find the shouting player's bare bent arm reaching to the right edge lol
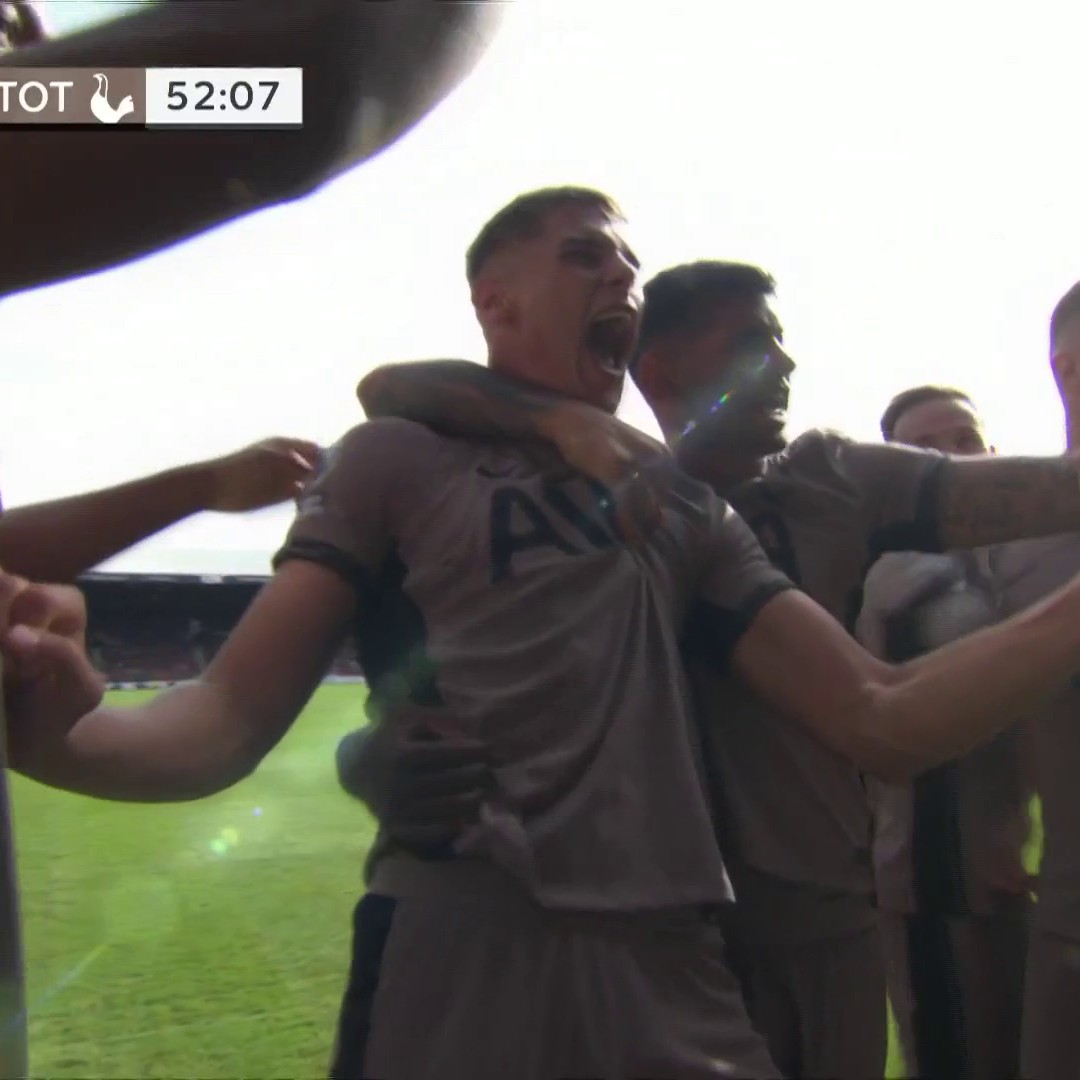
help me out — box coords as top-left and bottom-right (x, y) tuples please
(731, 581), (1080, 781)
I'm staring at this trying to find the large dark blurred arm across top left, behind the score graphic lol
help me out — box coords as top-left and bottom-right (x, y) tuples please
(0, 0), (502, 296)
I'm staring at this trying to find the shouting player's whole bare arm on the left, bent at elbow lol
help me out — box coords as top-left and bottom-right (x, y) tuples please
(9, 561), (355, 802)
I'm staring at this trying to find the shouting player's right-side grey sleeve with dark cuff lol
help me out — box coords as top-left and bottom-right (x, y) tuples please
(687, 499), (795, 665)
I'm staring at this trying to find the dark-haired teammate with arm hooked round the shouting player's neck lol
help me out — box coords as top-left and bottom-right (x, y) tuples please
(349, 254), (1080, 1080)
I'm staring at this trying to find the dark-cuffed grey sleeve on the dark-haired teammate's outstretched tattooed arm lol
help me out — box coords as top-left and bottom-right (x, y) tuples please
(823, 434), (948, 557)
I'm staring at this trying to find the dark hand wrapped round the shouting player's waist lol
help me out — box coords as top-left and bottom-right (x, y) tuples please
(337, 705), (492, 854)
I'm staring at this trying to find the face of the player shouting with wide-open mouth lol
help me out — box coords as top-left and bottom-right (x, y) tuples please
(473, 204), (642, 413)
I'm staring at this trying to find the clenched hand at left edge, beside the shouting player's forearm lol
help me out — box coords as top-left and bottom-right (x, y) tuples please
(0, 572), (105, 764)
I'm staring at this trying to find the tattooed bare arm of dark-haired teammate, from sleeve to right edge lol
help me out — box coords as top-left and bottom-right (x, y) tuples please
(940, 456), (1080, 551)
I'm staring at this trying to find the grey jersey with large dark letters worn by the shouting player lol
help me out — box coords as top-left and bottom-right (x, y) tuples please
(278, 420), (791, 910)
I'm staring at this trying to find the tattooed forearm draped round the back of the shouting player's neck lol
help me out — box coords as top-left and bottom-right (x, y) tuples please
(356, 360), (566, 441)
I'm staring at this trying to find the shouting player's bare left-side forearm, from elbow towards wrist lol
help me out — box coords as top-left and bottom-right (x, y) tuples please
(10, 681), (262, 802)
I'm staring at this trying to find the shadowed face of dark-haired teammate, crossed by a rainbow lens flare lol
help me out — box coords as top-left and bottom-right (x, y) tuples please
(642, 297), (795, 458)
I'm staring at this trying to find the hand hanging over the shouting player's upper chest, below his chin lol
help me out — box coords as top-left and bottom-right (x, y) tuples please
(541, 402), (670, 544)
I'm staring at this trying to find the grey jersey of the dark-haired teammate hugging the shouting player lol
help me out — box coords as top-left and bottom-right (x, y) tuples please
(688, 431), (945, 939)
